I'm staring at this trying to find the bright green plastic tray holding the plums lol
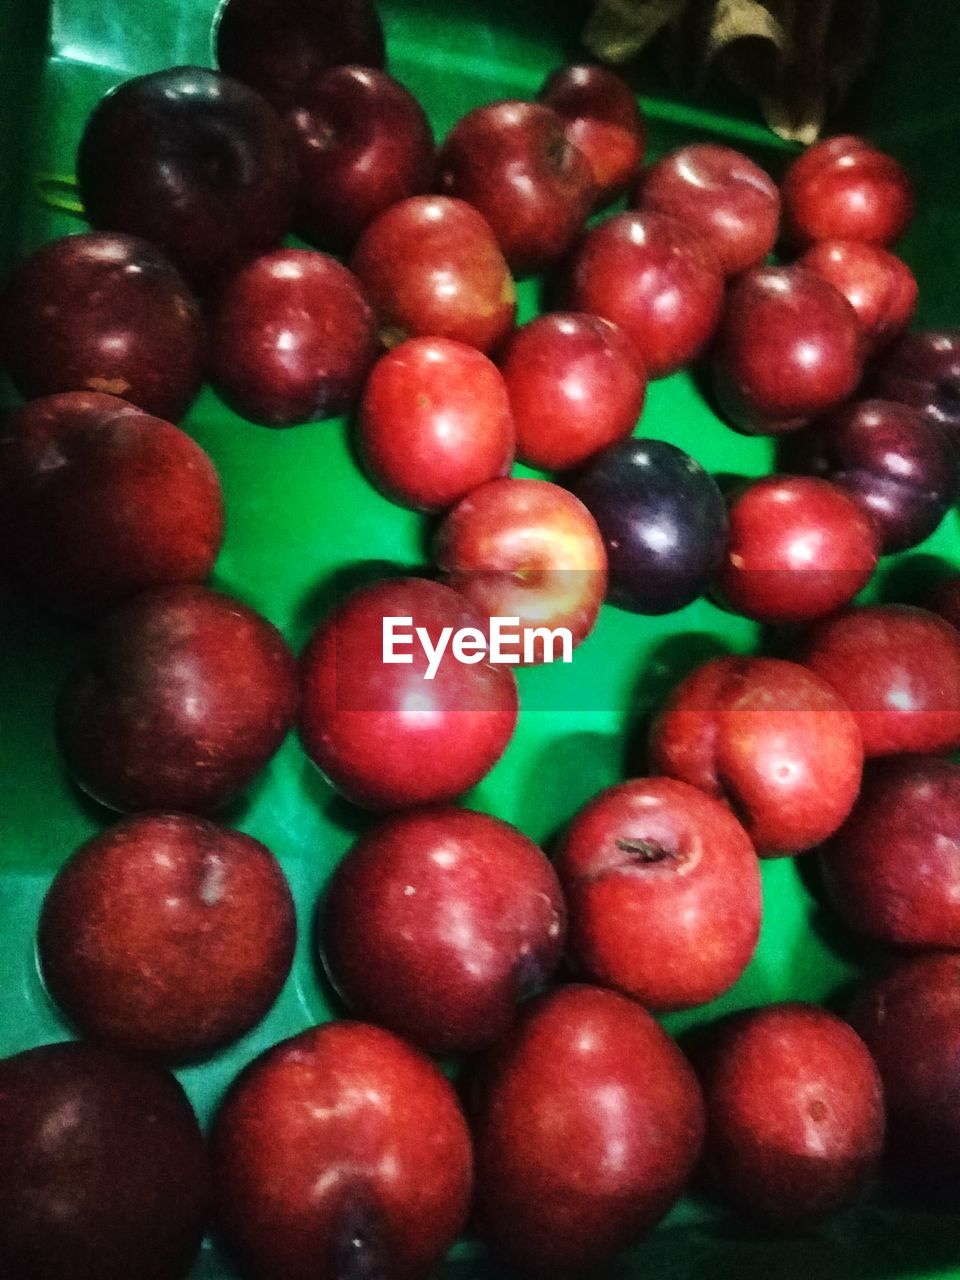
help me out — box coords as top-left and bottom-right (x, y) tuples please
(0, 0), (960, 1280)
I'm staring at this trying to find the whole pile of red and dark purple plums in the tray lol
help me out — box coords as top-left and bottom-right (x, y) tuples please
(0, 0), (960, 1280)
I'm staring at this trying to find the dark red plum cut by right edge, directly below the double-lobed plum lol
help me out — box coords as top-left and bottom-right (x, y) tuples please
(820, 755), (960, 950)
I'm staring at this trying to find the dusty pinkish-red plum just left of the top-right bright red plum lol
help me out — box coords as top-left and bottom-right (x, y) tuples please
(640, 142), (780, 275)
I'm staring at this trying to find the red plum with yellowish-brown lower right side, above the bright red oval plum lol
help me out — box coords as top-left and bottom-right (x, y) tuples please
(351, 196), (517, 352)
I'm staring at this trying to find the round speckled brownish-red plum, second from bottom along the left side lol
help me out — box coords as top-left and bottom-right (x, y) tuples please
(37, 813), (297, 1062)
